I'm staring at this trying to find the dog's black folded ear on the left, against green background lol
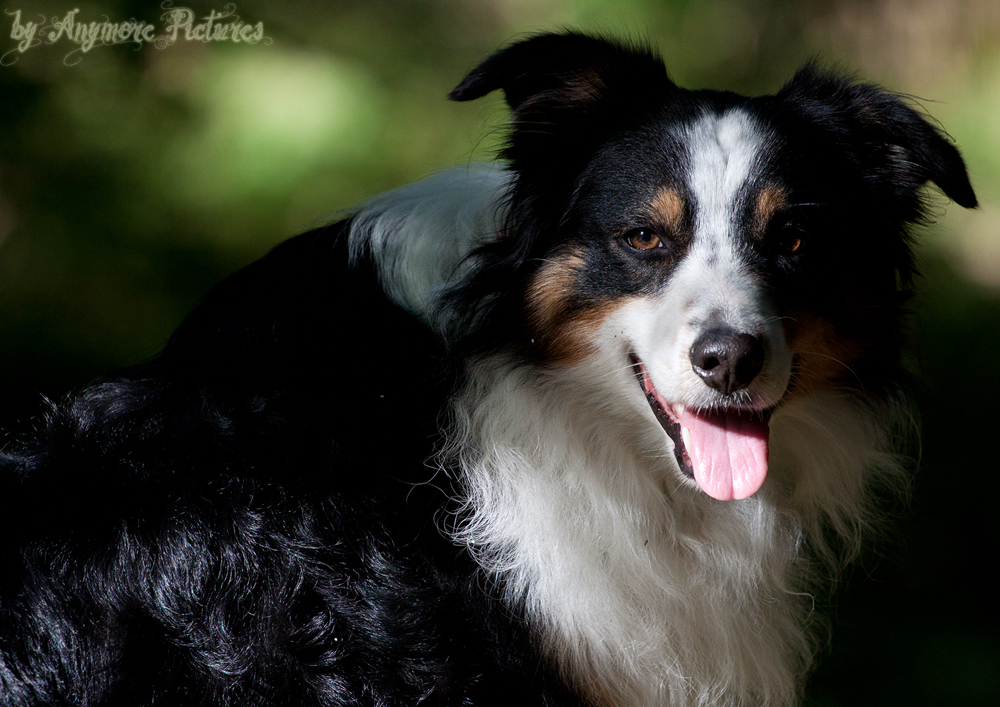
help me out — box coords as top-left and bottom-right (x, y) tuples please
(449, 33), (676, 167)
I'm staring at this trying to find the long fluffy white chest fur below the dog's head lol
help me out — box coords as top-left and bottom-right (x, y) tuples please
(446, 361), (896, 705)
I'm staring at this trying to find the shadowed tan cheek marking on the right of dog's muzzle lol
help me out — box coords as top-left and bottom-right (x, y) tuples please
(785, 311), (866, 394)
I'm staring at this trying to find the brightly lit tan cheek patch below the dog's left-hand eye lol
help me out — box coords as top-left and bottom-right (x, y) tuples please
(526, 253), (623, 365)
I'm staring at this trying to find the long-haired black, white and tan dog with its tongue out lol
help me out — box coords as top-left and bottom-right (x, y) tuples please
(0, 33), (976, 707)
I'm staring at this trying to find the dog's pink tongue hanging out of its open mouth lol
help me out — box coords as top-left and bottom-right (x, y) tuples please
(680, 409), (770, 501)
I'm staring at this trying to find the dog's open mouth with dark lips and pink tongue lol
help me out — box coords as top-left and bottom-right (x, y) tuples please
(632, 354), (772, 501)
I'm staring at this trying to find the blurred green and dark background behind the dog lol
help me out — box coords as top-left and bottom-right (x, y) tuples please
(0, 0), (1000, 707)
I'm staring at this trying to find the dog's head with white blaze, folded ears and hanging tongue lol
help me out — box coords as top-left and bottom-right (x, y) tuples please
(451, 34), (976, 499)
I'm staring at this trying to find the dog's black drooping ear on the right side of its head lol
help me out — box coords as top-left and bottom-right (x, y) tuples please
(778, 65), (977, 208)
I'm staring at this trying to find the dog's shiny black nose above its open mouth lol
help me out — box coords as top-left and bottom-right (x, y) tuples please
(691, 329), (764, 395)
